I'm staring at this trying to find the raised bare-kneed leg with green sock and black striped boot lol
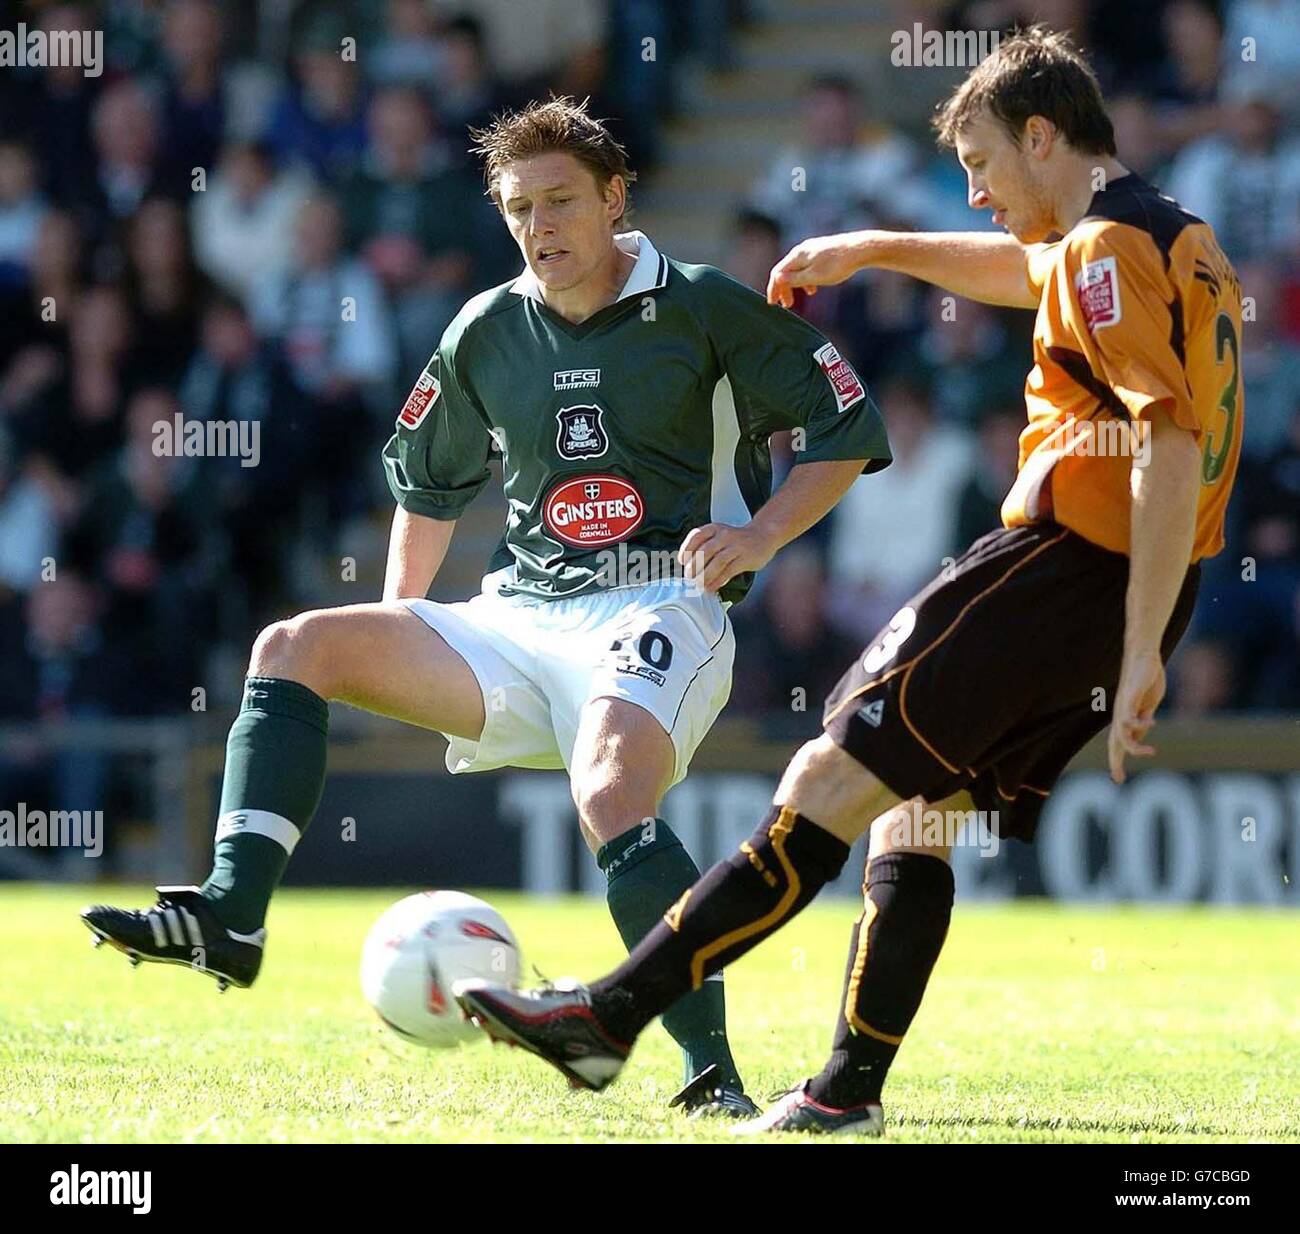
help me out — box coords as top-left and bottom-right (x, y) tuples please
(82, 602), (484, 988)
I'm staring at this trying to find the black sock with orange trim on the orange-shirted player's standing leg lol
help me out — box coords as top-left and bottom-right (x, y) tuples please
(809, 853), (953, 1109)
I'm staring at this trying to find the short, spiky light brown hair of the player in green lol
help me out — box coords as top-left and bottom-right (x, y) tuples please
(469, 95), (637, 222)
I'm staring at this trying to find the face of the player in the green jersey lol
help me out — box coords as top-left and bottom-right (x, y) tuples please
(497, 151), (627, 291)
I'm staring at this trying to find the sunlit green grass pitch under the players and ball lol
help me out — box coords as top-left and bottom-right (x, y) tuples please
(0, 884), (1300, 1143)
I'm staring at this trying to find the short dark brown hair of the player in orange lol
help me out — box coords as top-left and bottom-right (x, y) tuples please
(935, 25), (1115, 156)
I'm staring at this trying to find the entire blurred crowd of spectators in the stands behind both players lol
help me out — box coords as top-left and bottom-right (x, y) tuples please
(0, 0), (1300, 790)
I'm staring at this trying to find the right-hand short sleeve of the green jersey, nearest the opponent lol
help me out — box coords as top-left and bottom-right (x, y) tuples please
(707, 273), (891, 472)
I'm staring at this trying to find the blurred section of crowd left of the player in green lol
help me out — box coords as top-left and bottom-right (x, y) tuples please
(0, 0), (732, 748)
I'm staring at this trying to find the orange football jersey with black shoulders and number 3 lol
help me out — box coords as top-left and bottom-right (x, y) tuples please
(1002, 174), (1244, 562)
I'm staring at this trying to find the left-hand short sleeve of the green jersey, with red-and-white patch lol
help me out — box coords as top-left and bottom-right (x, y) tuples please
(384, 346), (491, 520)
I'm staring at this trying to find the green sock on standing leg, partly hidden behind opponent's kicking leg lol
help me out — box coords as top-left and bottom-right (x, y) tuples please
(595, 818), (740, 1083)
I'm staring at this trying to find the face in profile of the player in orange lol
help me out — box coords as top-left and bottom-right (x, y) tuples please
(957, 112), (1053, 244)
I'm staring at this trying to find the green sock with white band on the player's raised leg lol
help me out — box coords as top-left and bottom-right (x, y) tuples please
(200, 677), (329, 934)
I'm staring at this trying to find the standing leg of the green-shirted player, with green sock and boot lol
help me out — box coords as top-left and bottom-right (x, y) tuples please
(571, 698), (758, 1117)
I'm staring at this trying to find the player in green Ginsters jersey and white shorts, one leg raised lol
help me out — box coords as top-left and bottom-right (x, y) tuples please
(83, 99), (889, 1114)
